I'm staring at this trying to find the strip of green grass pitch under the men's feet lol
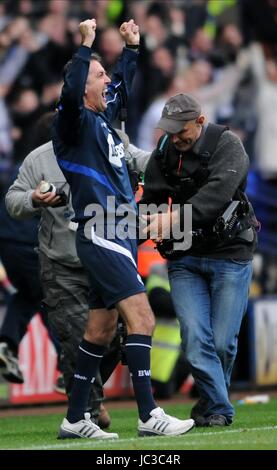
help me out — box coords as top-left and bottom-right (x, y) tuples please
(0, 399), (277, 451)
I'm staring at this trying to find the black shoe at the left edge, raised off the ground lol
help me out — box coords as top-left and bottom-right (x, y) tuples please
(0, 342), (24, 384)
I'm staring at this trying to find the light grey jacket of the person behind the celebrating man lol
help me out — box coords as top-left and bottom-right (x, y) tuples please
(6, 141), (151, 267)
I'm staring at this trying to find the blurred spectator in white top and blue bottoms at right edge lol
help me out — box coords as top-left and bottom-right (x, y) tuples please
(245, 43), (277, 295)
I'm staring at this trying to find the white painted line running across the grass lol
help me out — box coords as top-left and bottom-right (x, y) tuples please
(8, 426), (277, 450)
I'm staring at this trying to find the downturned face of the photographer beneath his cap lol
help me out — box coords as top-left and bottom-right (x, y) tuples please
(169, 116), (204, 152)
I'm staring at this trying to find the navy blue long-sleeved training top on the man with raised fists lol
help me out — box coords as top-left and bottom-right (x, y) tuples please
(53, 46), (138, 230)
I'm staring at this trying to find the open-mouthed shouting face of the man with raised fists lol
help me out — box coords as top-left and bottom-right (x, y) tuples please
(85, 60), (111, 113)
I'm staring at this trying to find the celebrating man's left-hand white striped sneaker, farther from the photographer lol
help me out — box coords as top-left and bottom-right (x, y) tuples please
(58, 413), (118, 439)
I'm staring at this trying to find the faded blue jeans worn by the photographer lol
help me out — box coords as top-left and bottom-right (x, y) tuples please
(168, 256), (252, 424)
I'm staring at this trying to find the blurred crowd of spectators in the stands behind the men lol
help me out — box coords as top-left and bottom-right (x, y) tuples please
(0, 0), (277, 295)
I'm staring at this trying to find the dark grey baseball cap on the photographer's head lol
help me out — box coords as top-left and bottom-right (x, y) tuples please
(157, 93), (201, 134)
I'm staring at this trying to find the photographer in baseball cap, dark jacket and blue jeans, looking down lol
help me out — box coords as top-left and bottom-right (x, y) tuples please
(141, 94), (256, 426)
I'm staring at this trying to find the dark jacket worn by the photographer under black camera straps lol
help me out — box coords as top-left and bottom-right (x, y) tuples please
(141, 127), (256, 260)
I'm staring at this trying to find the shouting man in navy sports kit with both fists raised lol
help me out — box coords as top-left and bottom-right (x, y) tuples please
(53, 19), (194, 438)
